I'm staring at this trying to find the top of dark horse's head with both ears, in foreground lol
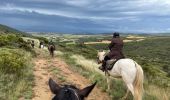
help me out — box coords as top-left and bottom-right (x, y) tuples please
(48, 78), (96, 100)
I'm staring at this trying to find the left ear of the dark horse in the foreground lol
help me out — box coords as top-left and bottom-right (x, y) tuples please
(48, 78), (61, 94)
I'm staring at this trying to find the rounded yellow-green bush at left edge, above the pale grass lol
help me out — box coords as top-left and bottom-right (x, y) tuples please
(0, 48), (27, 75)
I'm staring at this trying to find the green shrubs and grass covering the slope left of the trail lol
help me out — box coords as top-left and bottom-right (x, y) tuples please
(0, 31), (35, 100)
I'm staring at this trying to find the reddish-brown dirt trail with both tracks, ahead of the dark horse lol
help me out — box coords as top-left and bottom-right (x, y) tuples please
(32, 50), (110, 100)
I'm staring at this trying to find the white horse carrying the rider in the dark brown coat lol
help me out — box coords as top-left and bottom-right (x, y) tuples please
(98, 51), (144, 100)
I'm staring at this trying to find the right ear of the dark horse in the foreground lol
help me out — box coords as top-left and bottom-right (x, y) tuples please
(78, 82), (97, 97)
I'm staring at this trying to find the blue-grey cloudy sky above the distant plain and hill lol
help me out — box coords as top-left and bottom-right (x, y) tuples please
(0, 0), (170, 33)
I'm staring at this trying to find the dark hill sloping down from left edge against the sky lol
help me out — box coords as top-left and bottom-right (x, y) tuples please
(0, 24), (29, 36)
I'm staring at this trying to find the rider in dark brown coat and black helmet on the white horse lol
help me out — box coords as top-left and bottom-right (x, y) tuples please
(99, 32), (124, 71)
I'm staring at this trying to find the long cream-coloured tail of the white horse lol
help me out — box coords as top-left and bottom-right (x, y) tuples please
(133, 61), (144, 100)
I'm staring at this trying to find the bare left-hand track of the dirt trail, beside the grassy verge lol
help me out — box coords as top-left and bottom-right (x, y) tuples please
(32, 59), (51, 100)
